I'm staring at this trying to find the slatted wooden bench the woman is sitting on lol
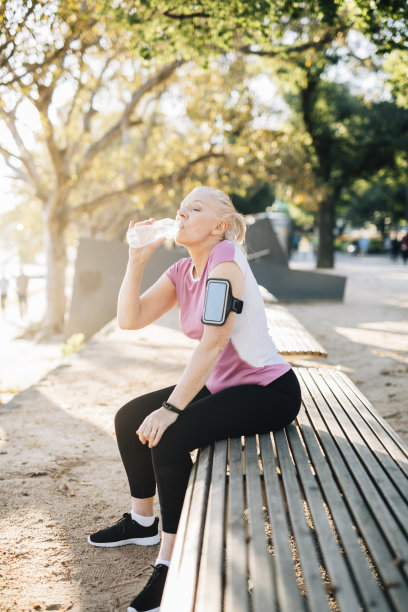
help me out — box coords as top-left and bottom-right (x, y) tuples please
(160, 368), (408, 612)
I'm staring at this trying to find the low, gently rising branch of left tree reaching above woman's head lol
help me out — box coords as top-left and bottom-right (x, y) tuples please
(67, 153), (225, 221)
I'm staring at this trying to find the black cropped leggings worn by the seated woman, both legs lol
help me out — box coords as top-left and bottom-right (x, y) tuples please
(115, 370), (300, 533)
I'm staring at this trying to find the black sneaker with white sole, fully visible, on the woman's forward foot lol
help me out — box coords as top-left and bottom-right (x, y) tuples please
(88, 512), (160, 548)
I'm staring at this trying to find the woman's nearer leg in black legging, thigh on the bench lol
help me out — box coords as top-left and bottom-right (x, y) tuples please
(152, 370), (301, 534)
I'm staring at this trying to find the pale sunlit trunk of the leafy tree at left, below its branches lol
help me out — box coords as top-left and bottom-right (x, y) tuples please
(42, 211), (67, 337)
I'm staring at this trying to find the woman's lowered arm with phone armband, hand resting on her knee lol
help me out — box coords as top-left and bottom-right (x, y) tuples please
(137, 262), (244, 448)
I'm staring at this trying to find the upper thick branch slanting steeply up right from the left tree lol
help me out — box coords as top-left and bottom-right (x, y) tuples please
(77, 60), (185, 174)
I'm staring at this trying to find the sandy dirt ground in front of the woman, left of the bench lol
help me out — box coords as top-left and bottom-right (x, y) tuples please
(0, 316), (197, 612)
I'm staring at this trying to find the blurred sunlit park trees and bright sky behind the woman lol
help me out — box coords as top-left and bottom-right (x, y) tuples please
(0, 0), (408, 400)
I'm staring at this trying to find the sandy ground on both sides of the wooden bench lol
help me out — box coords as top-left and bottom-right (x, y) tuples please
(0, 251), (408, 612)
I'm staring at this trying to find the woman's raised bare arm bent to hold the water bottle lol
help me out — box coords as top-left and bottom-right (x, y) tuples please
(117, 222), (177, 329)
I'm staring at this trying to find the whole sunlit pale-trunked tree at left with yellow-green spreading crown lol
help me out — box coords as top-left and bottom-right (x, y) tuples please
(4, 2), (302, 332)
